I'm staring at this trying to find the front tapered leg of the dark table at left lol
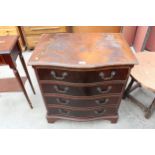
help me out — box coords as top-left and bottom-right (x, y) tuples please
(12, 68), (33, 109)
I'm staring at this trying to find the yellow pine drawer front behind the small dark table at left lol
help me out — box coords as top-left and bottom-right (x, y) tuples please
(0, 26), (18, 36)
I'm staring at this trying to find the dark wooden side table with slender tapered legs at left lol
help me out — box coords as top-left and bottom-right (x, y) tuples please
(0, 36), (35, 109)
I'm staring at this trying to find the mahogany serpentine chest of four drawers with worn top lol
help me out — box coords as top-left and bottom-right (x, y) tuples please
(29, 33), (137, 123)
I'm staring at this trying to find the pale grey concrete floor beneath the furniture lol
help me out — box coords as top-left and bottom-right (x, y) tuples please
(0, 51), (155, 129)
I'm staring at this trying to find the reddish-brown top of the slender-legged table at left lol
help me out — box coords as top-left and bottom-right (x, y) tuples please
(0, 36), (18, 55)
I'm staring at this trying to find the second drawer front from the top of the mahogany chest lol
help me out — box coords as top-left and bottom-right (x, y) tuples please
(42, 83), (124, 96)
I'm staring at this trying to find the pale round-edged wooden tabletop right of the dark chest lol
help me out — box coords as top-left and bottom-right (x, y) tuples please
(131, 52), (155, 92)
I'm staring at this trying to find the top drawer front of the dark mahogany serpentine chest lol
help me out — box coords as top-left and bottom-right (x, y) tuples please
(38, 68), (128, 83)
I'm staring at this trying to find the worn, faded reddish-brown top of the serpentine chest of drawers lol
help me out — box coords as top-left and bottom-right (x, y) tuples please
(29, 33), (137, 68)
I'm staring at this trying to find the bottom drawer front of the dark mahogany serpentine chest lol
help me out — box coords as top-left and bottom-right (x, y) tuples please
(48, 107), (117, 118)
